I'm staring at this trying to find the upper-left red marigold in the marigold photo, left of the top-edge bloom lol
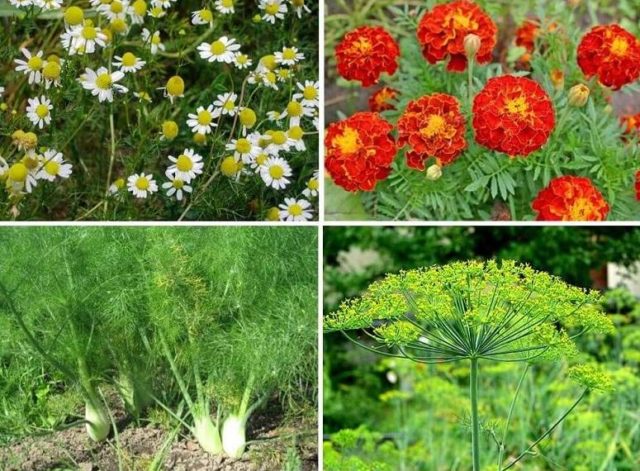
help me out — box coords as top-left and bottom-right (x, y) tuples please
(336, 26), (400, 87)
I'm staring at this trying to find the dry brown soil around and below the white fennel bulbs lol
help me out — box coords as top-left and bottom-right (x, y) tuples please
(0, 408), (318, 471)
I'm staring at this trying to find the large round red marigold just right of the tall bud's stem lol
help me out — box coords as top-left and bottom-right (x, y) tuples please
(473, 75), (555, 157)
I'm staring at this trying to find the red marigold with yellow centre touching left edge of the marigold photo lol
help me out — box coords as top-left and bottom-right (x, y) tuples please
(324, 111), (396, 191)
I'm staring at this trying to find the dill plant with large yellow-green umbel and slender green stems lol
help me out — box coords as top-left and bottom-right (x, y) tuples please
(324, 261), (614, 471)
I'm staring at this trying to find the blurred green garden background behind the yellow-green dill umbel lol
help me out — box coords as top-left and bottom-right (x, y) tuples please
(324, 227), (640, 471)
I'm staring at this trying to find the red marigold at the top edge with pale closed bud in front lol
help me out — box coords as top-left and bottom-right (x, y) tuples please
(418, 0), (498, 72)
